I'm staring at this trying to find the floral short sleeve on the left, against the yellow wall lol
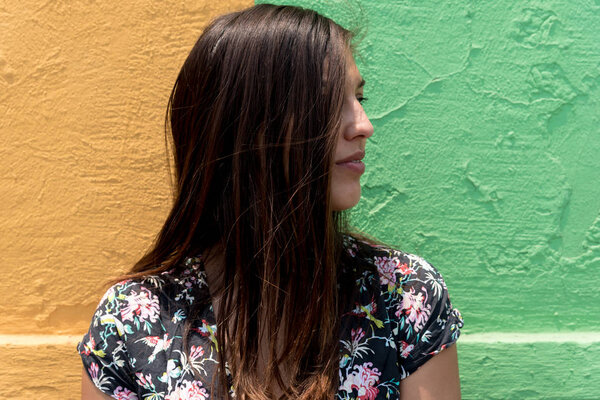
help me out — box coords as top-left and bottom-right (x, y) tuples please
(77, 281), (137, 399)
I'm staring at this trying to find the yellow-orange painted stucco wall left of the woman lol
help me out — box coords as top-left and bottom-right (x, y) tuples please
(0, 0), (253, 399)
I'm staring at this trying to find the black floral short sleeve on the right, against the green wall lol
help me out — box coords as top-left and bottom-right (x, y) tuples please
(390, 252), (463, 378)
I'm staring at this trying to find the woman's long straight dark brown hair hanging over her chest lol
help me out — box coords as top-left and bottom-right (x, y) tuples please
(129, 4), (352, 399)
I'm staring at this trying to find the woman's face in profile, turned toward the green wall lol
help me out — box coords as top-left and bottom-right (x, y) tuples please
(331, 51), (373, 211)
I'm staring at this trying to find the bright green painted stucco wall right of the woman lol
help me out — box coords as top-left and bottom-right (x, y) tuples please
(258, 0), (600, 399)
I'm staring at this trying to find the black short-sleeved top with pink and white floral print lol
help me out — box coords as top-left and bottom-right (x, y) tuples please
(78, 236), (463, 400)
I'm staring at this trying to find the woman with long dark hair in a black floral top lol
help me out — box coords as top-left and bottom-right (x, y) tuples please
(78, 5), (462, 400)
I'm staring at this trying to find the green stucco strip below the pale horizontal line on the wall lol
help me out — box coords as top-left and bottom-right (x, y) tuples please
(459, 342), (600, 400)
